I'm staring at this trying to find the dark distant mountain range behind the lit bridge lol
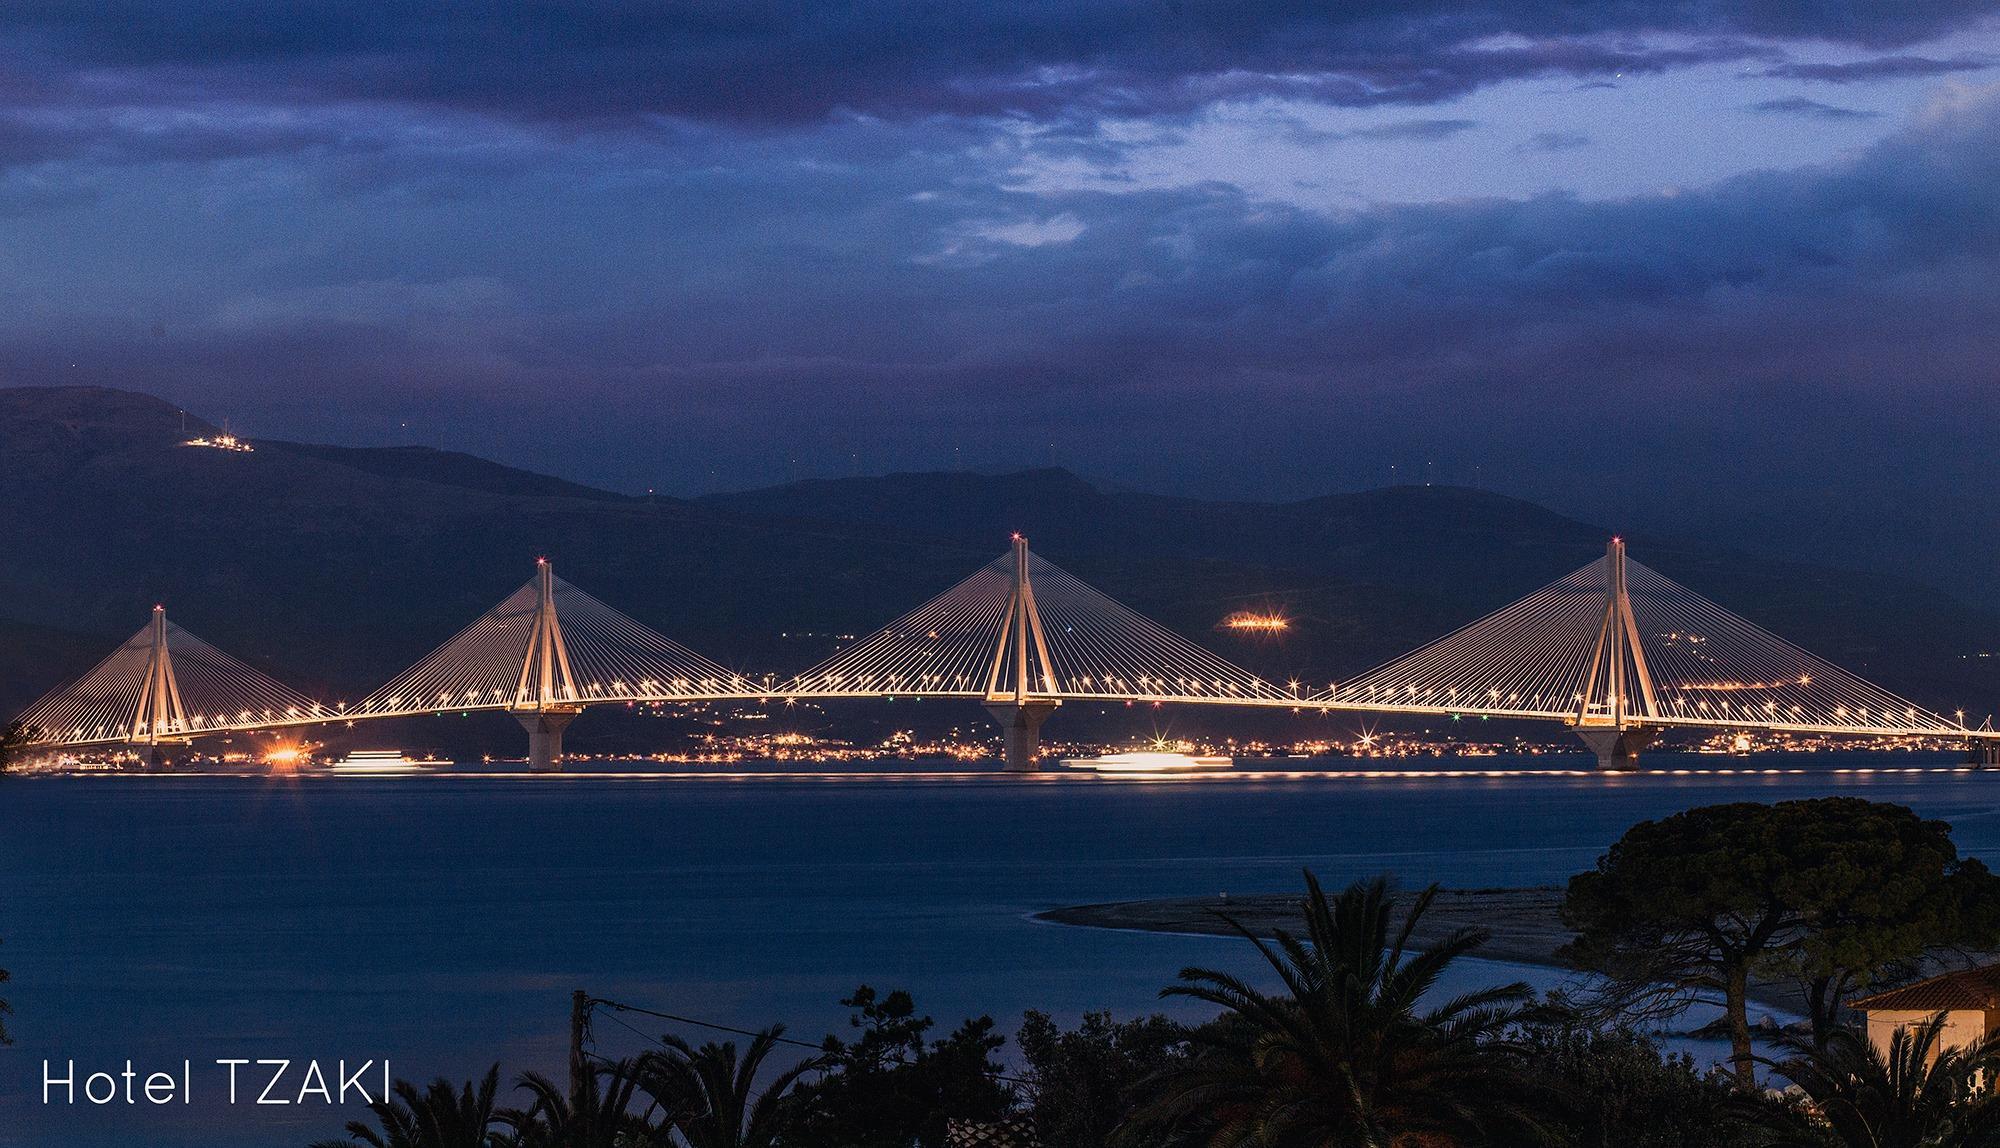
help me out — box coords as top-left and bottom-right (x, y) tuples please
(0, 388), (2000, 728)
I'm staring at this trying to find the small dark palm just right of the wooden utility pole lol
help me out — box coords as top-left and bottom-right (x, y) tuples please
(640, 1024), (820, 1148)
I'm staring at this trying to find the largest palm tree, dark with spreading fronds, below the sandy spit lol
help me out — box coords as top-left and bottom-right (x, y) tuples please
(1126, 870), (1546, 1148)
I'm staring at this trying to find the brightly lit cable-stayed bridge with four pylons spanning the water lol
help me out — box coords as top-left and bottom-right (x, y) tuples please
(7, 536), (2000, 770)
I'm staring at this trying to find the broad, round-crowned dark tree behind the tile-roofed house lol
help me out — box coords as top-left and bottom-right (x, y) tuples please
(1562, 798), (2000, 1088)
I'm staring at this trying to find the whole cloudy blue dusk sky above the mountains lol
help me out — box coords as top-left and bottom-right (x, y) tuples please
(0, 0), (2000, 592)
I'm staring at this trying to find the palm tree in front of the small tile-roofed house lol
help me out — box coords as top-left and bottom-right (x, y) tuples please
(1766, 1014), (2000, 1148)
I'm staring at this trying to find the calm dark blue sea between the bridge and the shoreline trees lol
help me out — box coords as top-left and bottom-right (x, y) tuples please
(0, 754), (2000, 1148)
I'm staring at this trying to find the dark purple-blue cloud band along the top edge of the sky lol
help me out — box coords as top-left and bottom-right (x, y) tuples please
(0, 0), (1994, 124)
